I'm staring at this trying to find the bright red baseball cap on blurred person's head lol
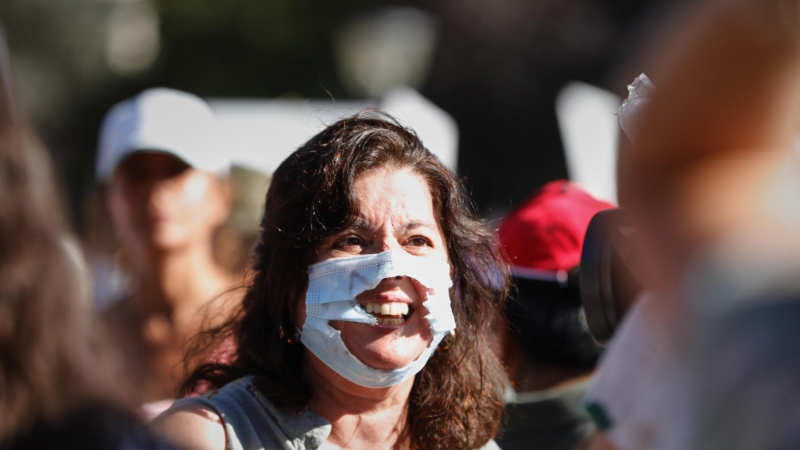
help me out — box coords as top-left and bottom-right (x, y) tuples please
(498, 180), (615, 274)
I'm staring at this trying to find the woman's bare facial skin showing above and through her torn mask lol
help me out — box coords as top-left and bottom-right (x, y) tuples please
(299, 167), (448, 369)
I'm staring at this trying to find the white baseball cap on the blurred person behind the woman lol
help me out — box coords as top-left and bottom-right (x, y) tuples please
(96, 88), (230, 182)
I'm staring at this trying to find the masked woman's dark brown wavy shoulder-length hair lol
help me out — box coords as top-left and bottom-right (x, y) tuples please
(182, 110), (508, 449)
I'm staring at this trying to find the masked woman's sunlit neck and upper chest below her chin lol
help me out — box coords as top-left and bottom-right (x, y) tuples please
(304, 351), (414, 449)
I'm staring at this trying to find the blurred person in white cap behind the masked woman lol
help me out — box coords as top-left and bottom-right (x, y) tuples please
(97, 88), (236, 413)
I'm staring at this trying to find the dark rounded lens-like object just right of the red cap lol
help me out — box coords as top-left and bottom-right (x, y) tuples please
(580, 208), (642, 345)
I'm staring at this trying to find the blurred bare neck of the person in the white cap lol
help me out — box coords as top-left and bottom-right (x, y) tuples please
(126, 244), (232, 316)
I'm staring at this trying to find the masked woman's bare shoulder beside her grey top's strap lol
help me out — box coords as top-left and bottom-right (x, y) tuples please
(152, 405), (226, 450)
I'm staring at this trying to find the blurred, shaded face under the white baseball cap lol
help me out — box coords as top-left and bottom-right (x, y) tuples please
(108, 152), (229, 259)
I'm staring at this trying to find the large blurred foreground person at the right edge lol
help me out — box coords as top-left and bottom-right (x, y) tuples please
(588, 0), (800, 450)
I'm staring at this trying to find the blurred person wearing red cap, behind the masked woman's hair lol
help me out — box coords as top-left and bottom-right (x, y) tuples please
(497, 180), (614, 450)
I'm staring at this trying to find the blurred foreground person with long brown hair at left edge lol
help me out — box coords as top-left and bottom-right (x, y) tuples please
(0, 38), (174, 450)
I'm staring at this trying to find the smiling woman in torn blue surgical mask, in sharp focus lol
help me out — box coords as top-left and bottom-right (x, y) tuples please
(156, 111), (508, 449)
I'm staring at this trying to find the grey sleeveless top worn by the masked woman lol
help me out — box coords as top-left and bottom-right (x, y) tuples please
(173, 376), (499, 450)
